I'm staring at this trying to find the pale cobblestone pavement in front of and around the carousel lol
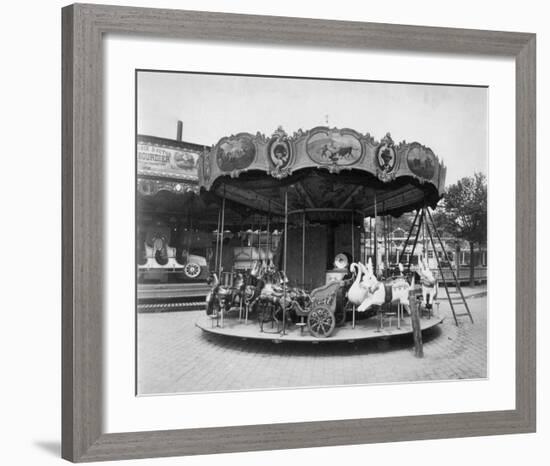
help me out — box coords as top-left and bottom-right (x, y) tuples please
(137, 289), (487, 394)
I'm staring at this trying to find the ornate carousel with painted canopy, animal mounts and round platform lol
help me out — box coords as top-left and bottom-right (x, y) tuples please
(196, 127), (469, 342)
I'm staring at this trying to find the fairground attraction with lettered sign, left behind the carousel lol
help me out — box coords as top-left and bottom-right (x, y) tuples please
(136, 135), (211, 283)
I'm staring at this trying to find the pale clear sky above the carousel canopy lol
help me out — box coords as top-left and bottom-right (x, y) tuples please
(137, 71), (487, 185)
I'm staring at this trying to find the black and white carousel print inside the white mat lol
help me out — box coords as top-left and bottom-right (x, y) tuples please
(135, 70), (490, 395)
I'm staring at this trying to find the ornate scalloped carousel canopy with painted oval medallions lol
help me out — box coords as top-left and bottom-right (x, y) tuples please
(198, 127), (446, 221)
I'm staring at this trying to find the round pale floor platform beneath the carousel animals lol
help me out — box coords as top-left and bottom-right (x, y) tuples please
(195, 315), (443, 343)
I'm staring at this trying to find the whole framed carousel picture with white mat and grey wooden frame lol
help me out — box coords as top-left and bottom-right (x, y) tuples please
(62, 4), (536, 462)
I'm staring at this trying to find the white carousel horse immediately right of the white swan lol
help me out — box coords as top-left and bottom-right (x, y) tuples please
(357, 257), (414, 314)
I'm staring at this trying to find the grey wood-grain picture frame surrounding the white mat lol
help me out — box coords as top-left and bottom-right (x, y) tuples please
(62, 4), (536, 462)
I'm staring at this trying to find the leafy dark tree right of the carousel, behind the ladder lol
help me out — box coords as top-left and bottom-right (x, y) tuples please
(440, 173), (487, 285)
